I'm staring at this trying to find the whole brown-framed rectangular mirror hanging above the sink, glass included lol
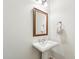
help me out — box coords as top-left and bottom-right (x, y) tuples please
(33, 8), (48, 36)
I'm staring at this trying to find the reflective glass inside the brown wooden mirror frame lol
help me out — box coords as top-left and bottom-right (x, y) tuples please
(36, 12), (46, 34)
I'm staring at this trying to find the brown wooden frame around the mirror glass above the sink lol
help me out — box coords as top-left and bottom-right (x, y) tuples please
(33, 8), (48, 36)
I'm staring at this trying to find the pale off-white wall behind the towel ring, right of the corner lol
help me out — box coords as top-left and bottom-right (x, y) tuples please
(48, 0), (75, 59)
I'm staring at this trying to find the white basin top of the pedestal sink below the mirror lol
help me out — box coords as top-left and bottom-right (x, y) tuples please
(33, 40), (58, 52)
